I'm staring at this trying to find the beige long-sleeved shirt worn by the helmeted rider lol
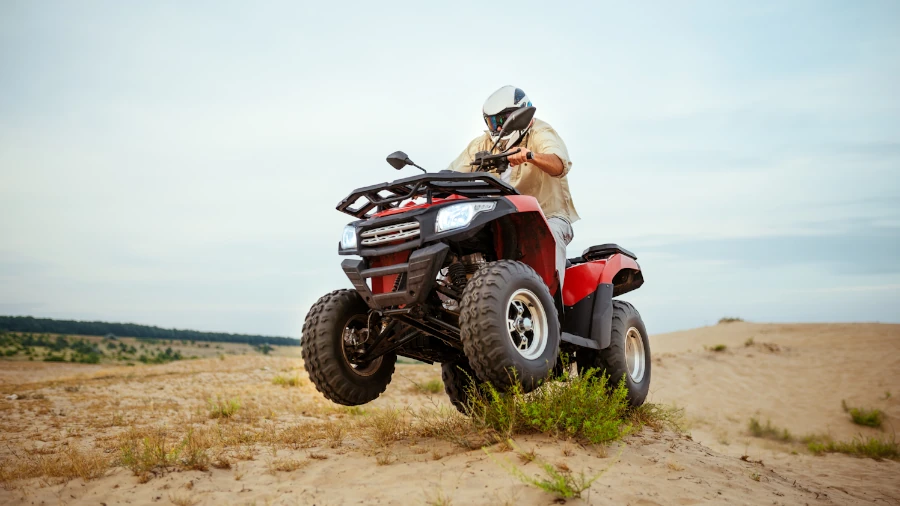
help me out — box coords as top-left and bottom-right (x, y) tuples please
(448, 118), (580, 223)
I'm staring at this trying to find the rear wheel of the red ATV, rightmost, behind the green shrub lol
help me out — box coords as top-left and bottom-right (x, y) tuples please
(576, 300), (651, 407)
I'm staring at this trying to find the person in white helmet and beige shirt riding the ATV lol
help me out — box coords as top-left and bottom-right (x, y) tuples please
(448, 86), (579, 286)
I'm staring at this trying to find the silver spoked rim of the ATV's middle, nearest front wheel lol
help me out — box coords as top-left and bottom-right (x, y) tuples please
(506, 288), (549, 360)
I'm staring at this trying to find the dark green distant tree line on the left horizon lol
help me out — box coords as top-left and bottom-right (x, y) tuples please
(0, 316), (300, 346)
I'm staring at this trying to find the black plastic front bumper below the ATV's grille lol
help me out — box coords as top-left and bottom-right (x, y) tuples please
(341, 243), (450, 309)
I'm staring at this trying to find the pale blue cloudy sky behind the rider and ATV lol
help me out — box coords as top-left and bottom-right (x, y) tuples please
(0, 0), (900, 337)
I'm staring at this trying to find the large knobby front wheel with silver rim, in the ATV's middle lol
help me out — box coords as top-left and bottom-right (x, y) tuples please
(459, 260), (559, 392)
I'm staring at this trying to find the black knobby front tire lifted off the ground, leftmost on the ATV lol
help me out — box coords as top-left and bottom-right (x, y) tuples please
(300, 290), (397, 406)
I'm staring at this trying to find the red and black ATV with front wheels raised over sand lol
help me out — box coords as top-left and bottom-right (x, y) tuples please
(301, 108), (650, 411)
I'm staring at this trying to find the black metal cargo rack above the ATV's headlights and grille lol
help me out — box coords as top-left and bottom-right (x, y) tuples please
(337, 170), (519, 219)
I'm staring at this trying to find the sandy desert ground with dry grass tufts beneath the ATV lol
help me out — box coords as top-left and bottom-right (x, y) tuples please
(0, 322), (900, 505)
